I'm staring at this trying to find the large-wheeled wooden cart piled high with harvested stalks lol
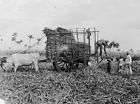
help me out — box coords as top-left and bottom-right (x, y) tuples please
(43, 27), (94, 71)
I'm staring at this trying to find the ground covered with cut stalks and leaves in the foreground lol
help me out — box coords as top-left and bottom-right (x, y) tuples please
(0, 57), (140, 104)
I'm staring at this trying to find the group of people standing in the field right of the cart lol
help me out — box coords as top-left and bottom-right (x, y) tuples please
(107, 53), (132, 75)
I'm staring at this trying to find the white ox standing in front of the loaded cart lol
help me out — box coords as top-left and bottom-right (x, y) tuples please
(2, 53), (40, 72)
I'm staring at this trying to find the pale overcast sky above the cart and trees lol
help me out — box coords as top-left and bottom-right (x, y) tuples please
(0, 0), (140, 50)
